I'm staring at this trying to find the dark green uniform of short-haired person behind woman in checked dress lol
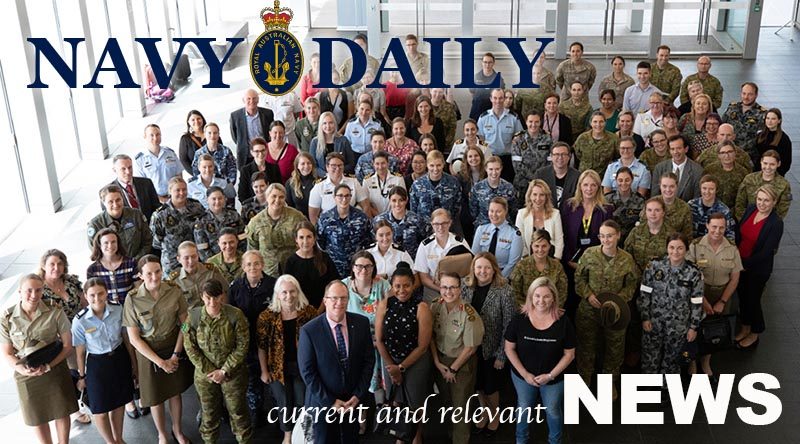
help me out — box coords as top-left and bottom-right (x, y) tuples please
(86, 207), (153, 261)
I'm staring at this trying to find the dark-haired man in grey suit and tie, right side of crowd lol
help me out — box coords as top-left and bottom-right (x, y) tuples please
(651, 134), (703, 202)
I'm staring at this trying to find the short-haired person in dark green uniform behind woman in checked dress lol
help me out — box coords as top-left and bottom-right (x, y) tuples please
(86, 185), (153, 261)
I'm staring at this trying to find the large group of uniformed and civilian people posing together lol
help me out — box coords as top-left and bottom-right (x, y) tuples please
(0, 35), (792, 444)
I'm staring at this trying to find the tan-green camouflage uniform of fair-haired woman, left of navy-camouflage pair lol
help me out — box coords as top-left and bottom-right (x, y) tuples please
(244, 207), (308, 278)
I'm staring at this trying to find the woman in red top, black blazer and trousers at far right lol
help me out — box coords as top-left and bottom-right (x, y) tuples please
(736, 185), (783, 350)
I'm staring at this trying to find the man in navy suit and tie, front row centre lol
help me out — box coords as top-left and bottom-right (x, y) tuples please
(297, 280), (375, 444)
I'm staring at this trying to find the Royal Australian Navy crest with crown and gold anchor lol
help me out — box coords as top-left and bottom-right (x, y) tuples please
(250, 0), (303, 96)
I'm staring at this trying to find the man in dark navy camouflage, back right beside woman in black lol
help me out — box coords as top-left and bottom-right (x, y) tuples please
(722, 82), (767, 163)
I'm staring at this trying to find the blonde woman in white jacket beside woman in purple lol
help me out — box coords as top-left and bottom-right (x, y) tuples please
(516, 179), (564, 259)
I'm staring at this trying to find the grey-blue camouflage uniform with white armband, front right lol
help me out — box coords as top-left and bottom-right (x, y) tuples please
(638, 258), (703, 374)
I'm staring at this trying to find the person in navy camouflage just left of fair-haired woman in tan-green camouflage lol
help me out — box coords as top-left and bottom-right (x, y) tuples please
(194, 187), (245, 262)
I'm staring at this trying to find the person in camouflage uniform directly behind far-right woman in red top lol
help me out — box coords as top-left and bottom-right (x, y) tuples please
(733, 150), (792, 220)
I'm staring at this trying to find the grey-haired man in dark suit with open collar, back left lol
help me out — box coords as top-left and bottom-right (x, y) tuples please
(230, 89), (275, 170)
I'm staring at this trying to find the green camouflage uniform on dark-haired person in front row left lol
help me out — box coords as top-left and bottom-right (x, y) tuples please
(182, 304), (253, 443)
